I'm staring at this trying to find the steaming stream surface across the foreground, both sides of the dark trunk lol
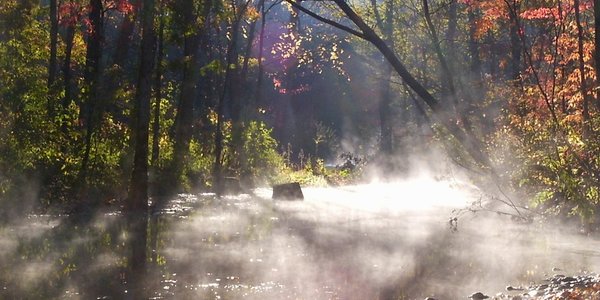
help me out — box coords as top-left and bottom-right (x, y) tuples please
(0, 178), (600, 299)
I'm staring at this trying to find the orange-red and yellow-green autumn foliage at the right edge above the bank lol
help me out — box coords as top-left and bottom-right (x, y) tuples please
(464, 1), (600, 224)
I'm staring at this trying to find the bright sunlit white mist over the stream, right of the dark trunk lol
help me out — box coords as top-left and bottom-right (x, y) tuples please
(154, 177), (600, 299)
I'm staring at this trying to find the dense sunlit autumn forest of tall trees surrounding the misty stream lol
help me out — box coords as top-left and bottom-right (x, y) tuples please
(0, 0), (600, 299)
